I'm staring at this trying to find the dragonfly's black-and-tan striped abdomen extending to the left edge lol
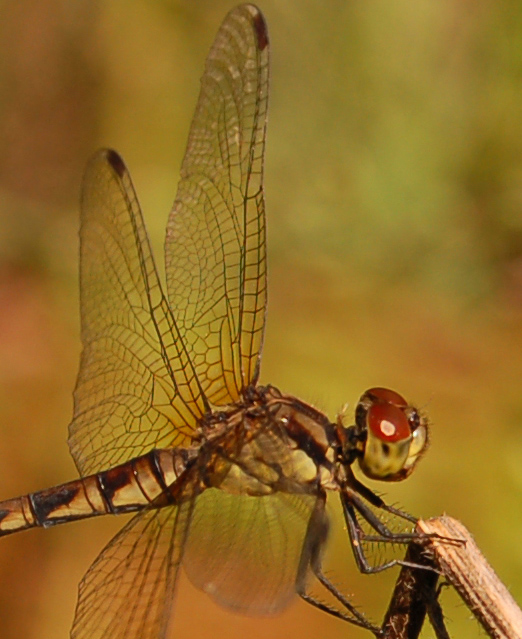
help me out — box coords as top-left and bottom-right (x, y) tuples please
(0, 449), (186, 536)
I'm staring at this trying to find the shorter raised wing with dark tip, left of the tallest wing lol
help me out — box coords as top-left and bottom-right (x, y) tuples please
(69, 151), (205, 474)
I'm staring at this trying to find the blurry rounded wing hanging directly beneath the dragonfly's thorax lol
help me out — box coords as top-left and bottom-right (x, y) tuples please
(183, 488), (317, 615)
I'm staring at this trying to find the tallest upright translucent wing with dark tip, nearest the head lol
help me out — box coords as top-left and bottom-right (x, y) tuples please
(165, 5), (268, 405)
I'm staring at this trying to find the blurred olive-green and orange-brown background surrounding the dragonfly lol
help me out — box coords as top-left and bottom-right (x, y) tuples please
(0, 0), (522, 639)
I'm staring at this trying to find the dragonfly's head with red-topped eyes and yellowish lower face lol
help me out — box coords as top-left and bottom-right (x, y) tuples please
(341, 388), (429, 481)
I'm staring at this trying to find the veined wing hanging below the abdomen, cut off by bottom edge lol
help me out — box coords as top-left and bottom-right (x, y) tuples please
(71, 503), (190, 639)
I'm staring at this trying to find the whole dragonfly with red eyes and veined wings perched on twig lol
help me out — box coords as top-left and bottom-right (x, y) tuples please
(0, 4), (429, 639)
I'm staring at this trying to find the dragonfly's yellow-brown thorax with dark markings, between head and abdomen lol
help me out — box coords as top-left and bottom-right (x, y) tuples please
(192, 386), (334, 496)
